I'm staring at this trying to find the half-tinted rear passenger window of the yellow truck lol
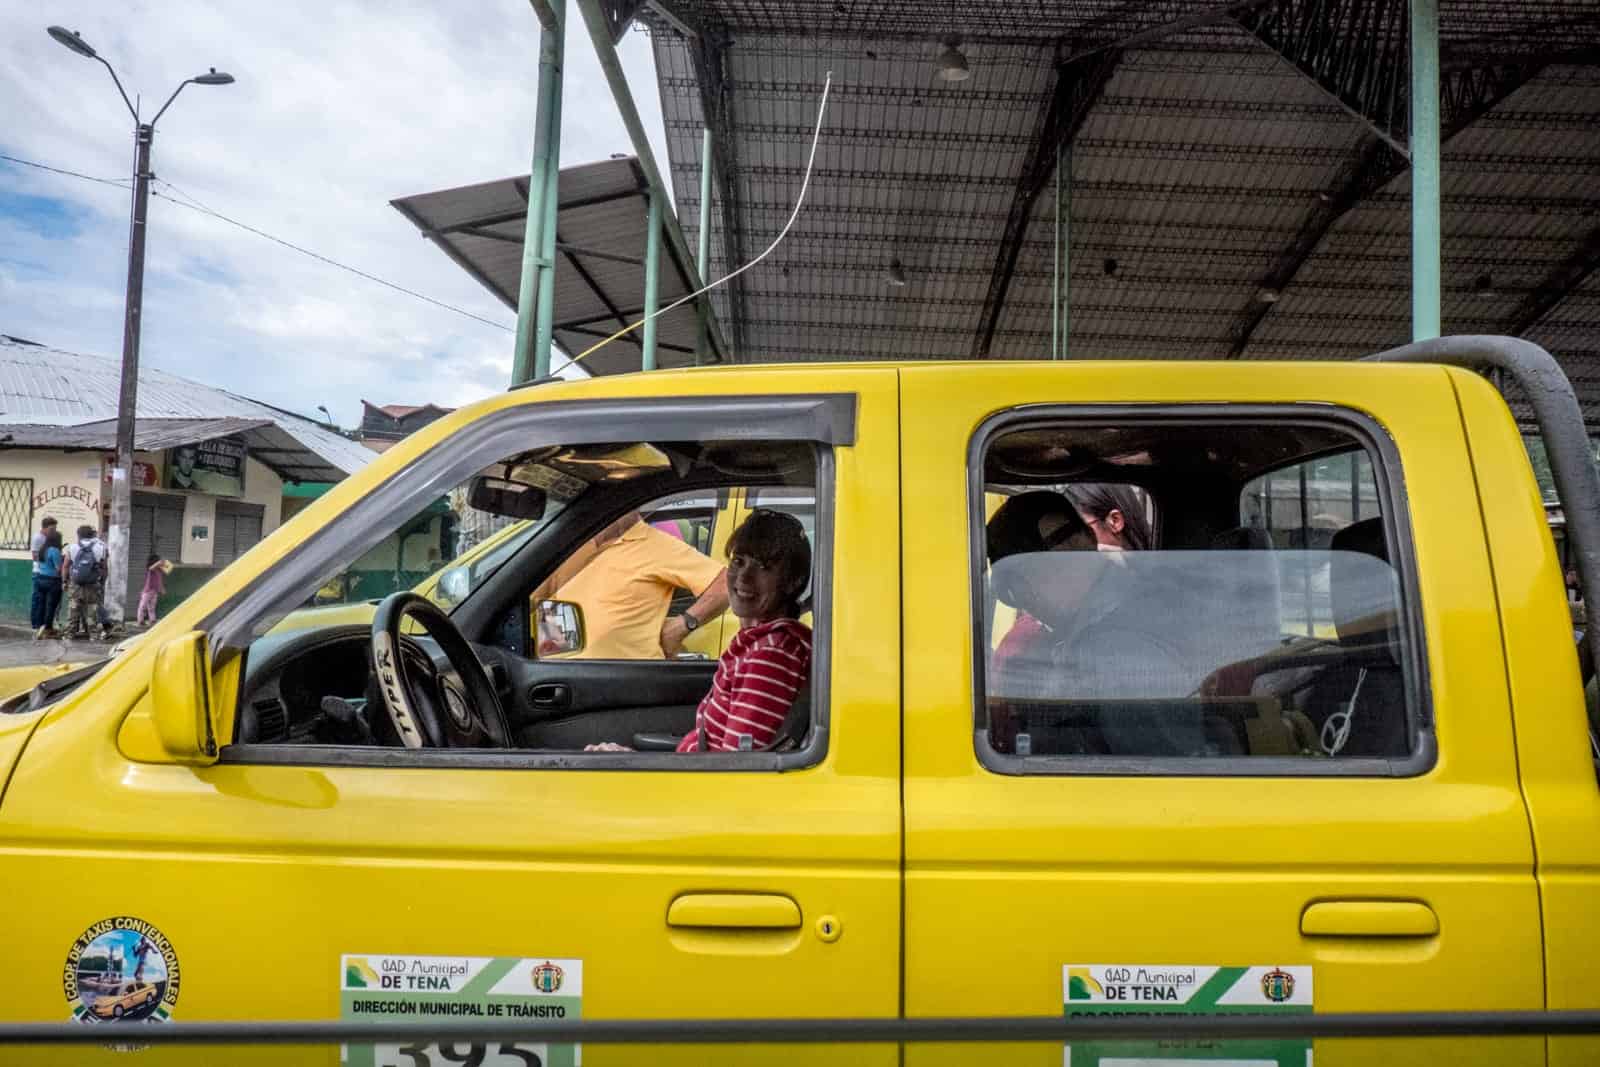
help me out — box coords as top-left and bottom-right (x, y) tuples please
(974, 416), (1427, 774)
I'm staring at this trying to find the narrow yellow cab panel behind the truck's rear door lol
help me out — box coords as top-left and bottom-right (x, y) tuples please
(1451, 371), (1600, 1065)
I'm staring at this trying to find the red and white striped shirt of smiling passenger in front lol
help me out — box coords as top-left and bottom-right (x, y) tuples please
(678, 619), (811, 752)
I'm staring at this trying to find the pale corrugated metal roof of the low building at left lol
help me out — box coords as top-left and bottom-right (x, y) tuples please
(0, 334), (374, 482)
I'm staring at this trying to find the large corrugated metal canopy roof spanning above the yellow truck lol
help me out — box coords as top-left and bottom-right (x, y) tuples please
(636, 0), (1600, 421)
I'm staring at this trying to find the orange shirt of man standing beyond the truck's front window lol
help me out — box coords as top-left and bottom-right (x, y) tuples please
(533, 512), (728, 659)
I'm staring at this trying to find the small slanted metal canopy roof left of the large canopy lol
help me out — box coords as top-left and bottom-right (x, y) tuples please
(390, 157), (723, 374)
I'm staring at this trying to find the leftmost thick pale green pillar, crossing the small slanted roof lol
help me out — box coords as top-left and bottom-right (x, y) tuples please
(510, 0), (566, 386)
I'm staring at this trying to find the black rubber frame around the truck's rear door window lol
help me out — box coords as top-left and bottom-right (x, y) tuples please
(966, 402), (1438, 777)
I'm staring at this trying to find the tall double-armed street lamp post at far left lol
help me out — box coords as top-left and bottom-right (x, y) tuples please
(46, 26), (234, 625)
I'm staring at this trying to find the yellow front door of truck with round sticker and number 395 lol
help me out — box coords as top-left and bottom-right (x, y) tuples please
(0, 370), (901, 1064)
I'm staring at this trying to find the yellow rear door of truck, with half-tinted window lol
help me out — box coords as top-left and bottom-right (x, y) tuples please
(901, 363), (1536, 1067)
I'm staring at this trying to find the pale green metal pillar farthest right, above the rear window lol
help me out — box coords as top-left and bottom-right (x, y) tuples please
(1411, 0), (1442, 341)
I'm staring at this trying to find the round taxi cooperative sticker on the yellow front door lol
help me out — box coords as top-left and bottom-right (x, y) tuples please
(61, 915), (179, 1022)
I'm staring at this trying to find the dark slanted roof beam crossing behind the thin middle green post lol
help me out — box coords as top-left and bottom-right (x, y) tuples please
(973, 50), (1122, 360)
